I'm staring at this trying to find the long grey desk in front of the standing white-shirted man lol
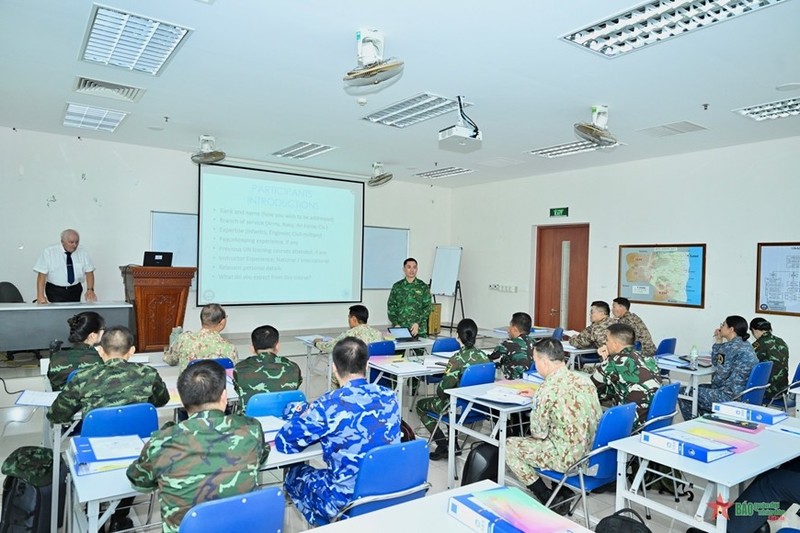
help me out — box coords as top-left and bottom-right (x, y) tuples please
(0, 302), (133, 352)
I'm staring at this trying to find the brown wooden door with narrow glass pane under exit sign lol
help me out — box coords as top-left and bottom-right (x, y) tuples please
(533, 224), (589, 331)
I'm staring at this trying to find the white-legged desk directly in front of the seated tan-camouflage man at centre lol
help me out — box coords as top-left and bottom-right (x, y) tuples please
(445, 379), (536, 488)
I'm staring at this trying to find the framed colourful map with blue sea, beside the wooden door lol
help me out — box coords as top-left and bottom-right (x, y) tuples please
(617, 244), (706, 308)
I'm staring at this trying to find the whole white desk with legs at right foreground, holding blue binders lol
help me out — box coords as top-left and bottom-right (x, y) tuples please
(609, 418), (800, 533)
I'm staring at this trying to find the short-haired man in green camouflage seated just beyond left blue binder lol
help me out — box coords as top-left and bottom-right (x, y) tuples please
(47, 326), (169, 531)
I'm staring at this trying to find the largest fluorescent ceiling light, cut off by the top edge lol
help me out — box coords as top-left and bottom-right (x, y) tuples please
(561, 0), (786, 58)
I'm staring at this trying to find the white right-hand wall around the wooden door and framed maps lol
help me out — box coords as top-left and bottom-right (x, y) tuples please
(452, 137), (800, 371)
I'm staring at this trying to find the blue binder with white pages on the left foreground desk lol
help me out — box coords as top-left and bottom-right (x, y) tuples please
(70, 435), (144, 476)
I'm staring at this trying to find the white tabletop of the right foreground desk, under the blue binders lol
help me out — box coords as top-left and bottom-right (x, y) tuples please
(609, 418), (800, 487)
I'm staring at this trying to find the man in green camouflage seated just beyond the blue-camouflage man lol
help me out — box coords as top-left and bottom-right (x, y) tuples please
(233, 326), (303, 413)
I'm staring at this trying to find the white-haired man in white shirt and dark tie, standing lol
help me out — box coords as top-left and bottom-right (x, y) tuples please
(33, 229), (97, 304)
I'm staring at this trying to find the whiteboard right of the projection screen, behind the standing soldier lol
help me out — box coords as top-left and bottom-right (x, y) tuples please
(362, 226), (409, 289)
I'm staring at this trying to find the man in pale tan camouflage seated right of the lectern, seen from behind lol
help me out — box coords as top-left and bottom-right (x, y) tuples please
(164, 304), (239, 371)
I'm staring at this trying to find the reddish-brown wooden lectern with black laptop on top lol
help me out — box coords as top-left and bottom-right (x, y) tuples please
(119, 265), (197, 352)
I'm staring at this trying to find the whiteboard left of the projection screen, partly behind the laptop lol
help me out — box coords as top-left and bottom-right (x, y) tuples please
(150, 211), (197, 267)
